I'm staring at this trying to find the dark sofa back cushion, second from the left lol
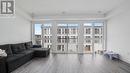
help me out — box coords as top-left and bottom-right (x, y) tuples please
(11, 43), (26, 54)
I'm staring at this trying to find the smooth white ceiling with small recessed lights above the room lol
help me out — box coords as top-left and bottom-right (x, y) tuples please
(16, 0), (126, 16)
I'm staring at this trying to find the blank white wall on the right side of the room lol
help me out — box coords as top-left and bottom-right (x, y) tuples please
(107, 3), (130, 63)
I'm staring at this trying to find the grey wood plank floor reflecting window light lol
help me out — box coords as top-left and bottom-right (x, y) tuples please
(12, 54), (130, 73)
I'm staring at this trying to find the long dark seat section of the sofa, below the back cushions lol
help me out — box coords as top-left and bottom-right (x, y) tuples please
(6, 54), (33, 73)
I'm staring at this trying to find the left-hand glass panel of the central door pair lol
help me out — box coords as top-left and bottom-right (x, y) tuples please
(56, 24), (68, 53)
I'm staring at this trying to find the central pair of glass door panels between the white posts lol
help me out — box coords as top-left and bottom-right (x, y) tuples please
(57, 23), (78, 53)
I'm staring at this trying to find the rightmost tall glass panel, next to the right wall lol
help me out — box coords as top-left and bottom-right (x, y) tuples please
(93, 23), (104, 53)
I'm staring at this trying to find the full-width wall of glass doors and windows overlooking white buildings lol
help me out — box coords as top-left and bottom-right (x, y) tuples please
(33, 21), (105, 53)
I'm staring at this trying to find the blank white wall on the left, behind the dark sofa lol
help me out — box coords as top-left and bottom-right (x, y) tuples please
(0, 8), (31, 44)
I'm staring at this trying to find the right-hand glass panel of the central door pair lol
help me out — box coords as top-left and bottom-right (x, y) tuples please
(67, 24), (79, 53)
